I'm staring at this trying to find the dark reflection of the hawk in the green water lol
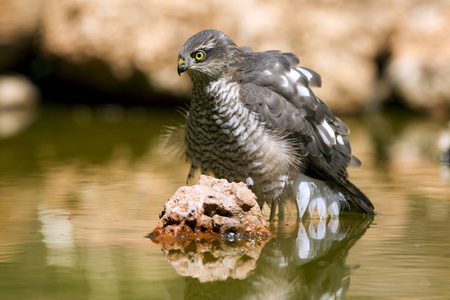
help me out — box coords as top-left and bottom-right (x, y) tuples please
(179, 215), (372, 299)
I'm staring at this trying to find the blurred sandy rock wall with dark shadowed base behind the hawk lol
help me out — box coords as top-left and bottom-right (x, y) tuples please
(0, 0), (450, 117)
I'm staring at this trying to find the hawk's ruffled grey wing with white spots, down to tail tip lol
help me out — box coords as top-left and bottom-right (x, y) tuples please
(233, 51), (373, 214)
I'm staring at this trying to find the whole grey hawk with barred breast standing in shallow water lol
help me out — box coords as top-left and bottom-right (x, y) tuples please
(178, 30), (373, 219)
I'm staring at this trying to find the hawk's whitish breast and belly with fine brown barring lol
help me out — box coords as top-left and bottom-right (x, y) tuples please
(185, 79), (296, 205)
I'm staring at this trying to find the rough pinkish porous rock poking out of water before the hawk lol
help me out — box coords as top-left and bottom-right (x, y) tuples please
(150, 176), (271, 243)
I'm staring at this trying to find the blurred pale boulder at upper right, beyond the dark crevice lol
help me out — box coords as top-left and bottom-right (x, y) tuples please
(386, 1), (450, 115)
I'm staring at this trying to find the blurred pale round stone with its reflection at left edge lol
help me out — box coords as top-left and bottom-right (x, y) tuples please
(0, 76), (39, 139)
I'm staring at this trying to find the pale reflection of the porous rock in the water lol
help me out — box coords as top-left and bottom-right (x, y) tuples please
(163, 240), (268, 282)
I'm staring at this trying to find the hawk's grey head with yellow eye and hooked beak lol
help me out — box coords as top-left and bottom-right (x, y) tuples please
(178, 30), (239, 81)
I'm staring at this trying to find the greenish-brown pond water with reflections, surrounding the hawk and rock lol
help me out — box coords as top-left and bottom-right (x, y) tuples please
(0, 105), (450, 299)
